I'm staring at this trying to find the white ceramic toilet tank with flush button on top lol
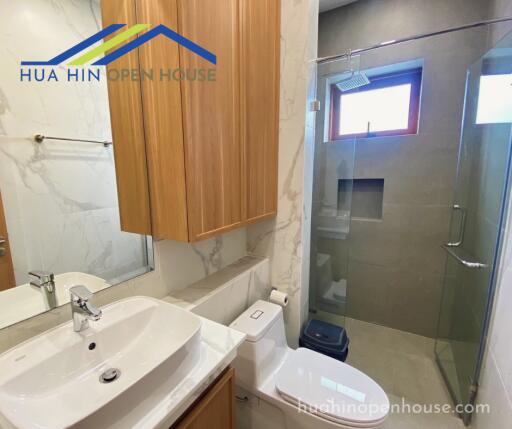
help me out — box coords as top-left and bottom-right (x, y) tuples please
(229, 300), (288, 390)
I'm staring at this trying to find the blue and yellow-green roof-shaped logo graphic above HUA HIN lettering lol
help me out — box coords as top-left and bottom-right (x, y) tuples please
(21, 24), (217, 66)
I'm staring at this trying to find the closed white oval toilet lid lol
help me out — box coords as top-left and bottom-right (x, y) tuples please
(275, 348), (390, 427)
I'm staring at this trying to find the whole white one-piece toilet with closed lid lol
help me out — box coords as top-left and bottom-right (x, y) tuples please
(230, 301), (390, 429)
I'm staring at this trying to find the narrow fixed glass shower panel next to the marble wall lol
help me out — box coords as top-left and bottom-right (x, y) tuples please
(309, 57), (359, 325)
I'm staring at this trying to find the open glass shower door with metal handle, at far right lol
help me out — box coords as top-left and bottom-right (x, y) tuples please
(436, 30), (512, 423)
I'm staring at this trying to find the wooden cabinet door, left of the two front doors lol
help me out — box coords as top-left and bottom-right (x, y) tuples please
(178, 0), (245, 241)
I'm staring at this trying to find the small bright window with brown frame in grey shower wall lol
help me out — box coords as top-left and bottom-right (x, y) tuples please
(330, 68), (422, 140)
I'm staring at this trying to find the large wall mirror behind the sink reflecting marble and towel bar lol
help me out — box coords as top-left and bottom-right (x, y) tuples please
(0, 0), (153, 328)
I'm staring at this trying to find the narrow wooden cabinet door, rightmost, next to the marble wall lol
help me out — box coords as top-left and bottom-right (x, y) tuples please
(240, 0), (281, 222)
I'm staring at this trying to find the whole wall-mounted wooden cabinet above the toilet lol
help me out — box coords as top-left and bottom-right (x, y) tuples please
(102, 0), (280, 242)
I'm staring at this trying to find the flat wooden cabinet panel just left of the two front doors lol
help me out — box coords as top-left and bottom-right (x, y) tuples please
(136, 0), (188, 241)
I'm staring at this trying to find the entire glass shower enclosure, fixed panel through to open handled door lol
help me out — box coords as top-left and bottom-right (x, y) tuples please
(309, 17), (512, 424)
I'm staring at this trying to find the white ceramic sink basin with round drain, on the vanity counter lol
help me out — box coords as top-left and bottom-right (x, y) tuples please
(0, 297), (201, 429)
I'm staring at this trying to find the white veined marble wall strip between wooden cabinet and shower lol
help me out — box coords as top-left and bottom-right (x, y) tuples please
(247, 0), (318, 345)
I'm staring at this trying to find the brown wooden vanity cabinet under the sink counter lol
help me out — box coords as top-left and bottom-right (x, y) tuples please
(172, 368), (236, 429)
